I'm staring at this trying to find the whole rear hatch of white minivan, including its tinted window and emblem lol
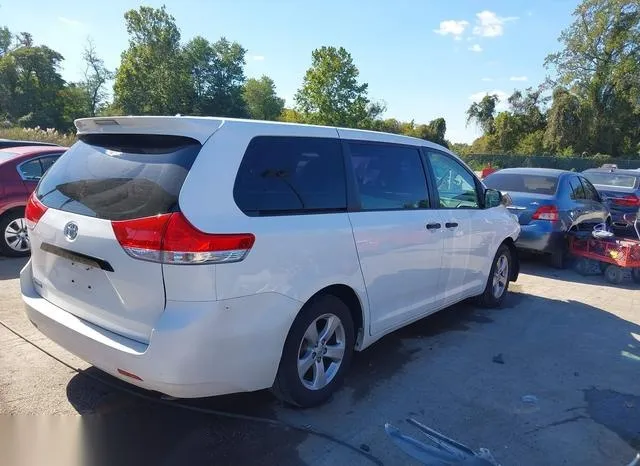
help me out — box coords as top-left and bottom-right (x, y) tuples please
(26, 134), (201, 343)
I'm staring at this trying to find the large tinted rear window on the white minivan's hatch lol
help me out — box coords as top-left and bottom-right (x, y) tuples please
(37, 134), (201, 220)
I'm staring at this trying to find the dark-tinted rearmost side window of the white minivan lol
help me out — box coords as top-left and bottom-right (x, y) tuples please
(233, 136), (347, 216)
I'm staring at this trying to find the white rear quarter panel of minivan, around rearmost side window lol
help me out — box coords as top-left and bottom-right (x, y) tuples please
(179, 121), (369, 328)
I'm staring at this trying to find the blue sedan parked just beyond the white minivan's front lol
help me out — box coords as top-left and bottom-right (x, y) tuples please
(484, 168), (611, 268)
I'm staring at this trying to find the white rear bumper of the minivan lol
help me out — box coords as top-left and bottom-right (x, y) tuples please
(20, 262), (300, 398)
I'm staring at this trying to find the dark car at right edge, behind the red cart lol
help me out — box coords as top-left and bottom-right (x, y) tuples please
(582, 165), (640, 236)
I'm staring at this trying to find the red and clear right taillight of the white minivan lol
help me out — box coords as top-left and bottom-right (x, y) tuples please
(111, 212), (255, 264)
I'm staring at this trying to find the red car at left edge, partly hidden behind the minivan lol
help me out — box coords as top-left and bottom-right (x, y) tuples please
(0, 146), (67, 257)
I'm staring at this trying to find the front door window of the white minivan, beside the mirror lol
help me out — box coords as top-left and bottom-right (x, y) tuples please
(429, 152), (480, 209)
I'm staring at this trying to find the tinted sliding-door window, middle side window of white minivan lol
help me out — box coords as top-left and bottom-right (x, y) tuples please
(349, 142), (429, 210)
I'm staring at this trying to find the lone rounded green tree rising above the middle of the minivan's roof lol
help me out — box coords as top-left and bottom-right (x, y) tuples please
(295, 47), (384, 128)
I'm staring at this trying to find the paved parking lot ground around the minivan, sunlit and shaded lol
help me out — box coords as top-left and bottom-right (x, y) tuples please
(0, 259), (640, 466)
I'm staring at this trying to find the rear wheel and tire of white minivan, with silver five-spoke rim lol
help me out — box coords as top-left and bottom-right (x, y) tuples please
(271, 295), (355, 408)
